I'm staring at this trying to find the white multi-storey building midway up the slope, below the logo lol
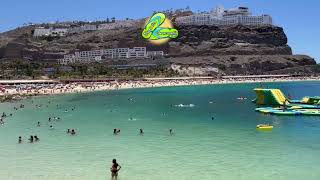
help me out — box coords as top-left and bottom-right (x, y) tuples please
(58, 47), (164, 65)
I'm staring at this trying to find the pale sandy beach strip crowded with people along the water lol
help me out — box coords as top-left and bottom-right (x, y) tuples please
(0, 77), (320, 102)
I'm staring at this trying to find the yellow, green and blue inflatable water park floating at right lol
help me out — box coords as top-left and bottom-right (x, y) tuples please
(252, 88), (320, 116)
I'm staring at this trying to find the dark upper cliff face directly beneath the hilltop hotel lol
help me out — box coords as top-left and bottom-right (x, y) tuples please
(170, 26), (292, 56)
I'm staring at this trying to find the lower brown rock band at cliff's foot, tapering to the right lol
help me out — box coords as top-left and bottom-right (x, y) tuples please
(169, 55), (315, 75)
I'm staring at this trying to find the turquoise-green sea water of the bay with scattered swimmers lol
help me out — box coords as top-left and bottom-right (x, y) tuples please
(0, 82), (320, 180)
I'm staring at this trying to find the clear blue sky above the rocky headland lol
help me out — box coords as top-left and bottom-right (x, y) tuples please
(0, 0), (320, 63)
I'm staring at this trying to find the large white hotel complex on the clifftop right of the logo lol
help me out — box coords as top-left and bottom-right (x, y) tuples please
(176, 7), (272, 26)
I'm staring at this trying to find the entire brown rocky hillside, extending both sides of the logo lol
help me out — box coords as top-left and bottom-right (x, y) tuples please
(0, 22), (316, 74)
